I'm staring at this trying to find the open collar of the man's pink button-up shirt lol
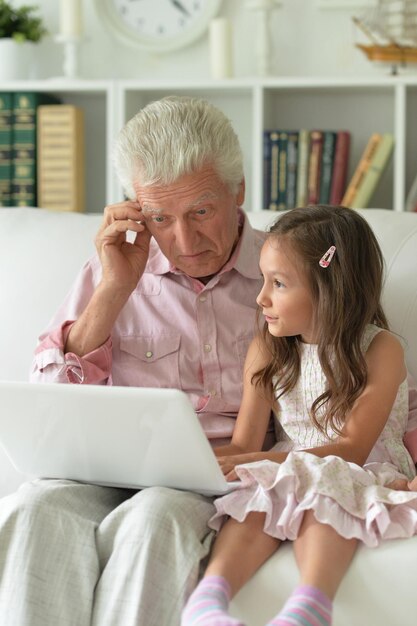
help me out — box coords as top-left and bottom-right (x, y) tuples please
(146, 209), (262, 278)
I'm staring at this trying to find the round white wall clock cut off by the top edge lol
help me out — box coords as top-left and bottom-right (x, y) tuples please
(95, 0), (222, 52)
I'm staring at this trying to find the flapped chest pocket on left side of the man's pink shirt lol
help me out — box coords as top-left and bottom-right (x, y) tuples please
(120, 333), (181, 389)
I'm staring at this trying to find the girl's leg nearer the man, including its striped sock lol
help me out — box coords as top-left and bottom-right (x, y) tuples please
(181, 513), (280, 626)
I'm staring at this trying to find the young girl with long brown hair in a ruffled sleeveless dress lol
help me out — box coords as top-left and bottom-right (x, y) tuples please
(182, 206), (417, 626)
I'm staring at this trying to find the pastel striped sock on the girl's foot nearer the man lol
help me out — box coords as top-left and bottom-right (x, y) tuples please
(181, 576), (243, 626)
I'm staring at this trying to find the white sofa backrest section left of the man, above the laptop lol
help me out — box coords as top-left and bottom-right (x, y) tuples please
(0, 208), (101, 380)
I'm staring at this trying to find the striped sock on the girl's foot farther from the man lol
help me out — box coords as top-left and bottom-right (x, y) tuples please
(267, 585), (332, 626)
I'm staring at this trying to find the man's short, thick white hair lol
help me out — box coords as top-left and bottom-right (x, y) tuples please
(113, 96), (243, 199)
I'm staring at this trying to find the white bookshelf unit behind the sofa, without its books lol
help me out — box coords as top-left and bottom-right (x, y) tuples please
(0, 75), (417, 212)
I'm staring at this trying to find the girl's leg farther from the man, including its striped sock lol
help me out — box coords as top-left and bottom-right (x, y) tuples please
(269, 511), (358, 626)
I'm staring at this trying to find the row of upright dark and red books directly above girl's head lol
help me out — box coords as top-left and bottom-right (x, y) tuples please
(264, 130), (350, 211)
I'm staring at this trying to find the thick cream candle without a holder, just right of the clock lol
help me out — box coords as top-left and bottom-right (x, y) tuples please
(209, 17), (233, 78)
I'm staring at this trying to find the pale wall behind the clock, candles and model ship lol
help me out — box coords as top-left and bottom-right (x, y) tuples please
(19, 0), (387, 79)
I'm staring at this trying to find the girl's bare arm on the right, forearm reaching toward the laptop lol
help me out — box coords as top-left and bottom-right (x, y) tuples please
(221, 331), (407, 480)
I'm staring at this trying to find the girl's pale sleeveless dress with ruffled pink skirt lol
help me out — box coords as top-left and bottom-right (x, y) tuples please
(209, 325), (417, 547)
